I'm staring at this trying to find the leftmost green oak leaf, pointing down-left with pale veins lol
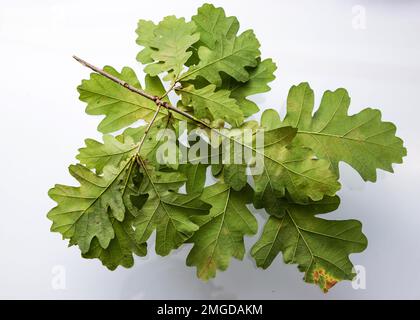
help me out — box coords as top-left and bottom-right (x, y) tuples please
(48, 159), (138, 253)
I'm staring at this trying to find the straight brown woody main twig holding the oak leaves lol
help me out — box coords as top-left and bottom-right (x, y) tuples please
(73, 56), (212, 129)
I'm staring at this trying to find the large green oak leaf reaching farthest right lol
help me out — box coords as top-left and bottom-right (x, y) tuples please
(272, 83), (407, 181)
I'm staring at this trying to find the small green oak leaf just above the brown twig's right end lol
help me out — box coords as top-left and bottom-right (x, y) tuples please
(177, 84), (244, 127)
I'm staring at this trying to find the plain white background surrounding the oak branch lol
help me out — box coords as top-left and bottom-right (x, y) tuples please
(0, 0), (420, 299)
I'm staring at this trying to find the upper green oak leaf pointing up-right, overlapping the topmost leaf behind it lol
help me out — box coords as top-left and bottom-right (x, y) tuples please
(179, 30), (260, 87)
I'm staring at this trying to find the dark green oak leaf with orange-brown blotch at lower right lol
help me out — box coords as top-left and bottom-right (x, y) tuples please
(251, 197), (367, 292)
